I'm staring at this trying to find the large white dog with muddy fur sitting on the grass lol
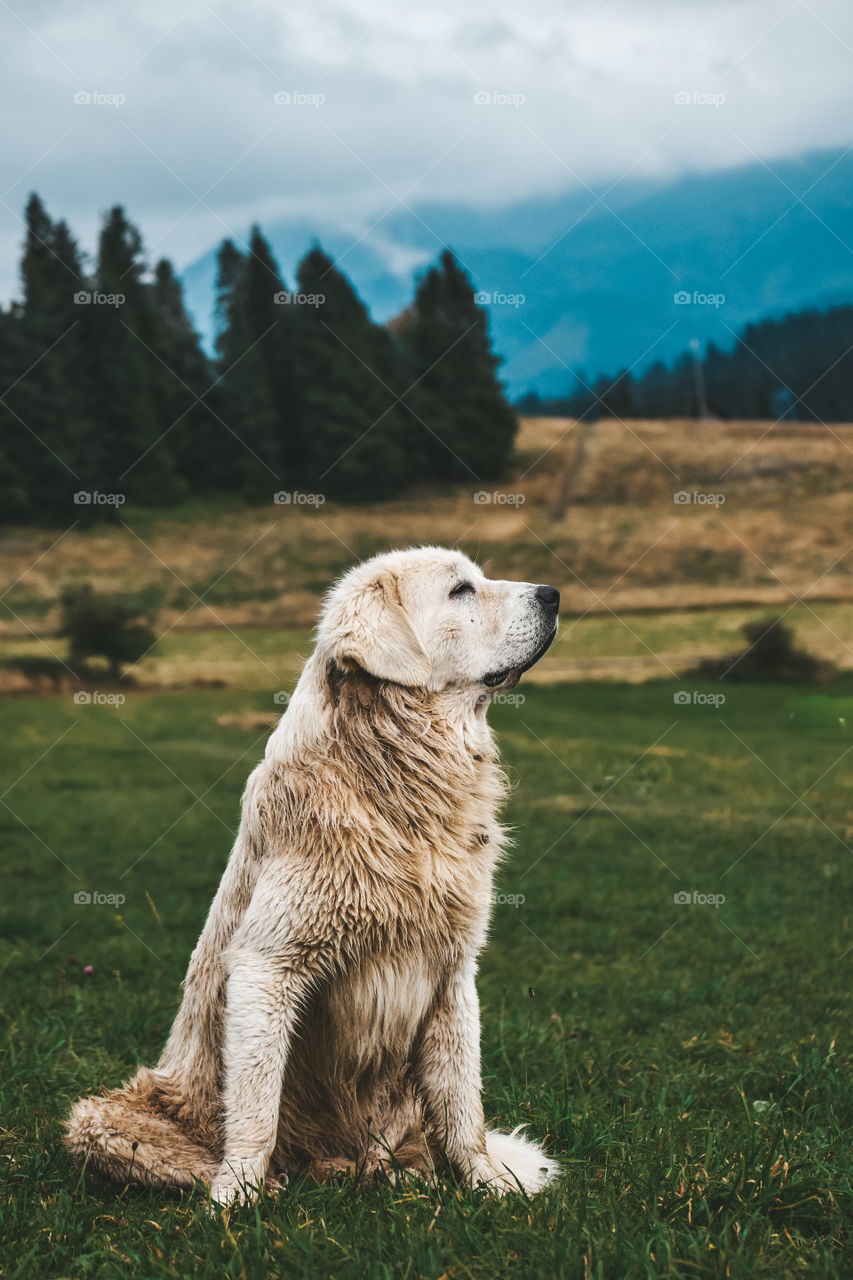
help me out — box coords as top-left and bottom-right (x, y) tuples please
(67, 548), (560, 1204)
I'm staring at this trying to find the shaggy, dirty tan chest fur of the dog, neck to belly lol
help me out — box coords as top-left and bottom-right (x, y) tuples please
(256, 680), (503, 1079)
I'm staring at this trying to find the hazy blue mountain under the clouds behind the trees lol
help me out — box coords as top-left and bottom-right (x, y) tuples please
(183, 151), (853, 396)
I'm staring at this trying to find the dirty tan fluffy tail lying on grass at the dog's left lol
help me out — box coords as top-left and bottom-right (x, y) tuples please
(65, 1070), (219, 1187)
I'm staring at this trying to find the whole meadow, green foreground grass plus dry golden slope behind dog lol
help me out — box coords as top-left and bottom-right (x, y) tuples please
(0, 424), (853, 1280)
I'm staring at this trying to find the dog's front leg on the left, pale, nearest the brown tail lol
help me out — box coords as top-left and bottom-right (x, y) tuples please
(210, 943), (306, 1204)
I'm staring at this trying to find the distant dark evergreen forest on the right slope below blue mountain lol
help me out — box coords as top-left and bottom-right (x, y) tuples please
(516, 306), (853, 422)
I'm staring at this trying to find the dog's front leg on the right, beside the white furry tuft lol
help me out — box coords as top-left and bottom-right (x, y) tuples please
(415, 957), (494, 1185)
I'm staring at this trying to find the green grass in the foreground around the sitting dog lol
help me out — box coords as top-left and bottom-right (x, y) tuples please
(0, 677), (853, 1280)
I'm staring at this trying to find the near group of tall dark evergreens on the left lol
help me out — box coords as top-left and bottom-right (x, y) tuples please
(0, 195), (516, 522)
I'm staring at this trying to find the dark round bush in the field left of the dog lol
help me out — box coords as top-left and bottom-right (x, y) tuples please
(59, 582), (156, 678)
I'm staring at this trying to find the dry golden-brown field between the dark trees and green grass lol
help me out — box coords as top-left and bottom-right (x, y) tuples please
(0, 419), (853, 691)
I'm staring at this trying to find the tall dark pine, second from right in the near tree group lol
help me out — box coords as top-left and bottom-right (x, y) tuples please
(295, 247), (407, 502)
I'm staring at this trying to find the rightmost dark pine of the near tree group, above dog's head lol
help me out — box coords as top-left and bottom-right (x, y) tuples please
(402, 251), (517, 480)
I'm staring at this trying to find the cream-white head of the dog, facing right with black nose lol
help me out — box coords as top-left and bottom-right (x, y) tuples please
(319, 547), (560, 692)
